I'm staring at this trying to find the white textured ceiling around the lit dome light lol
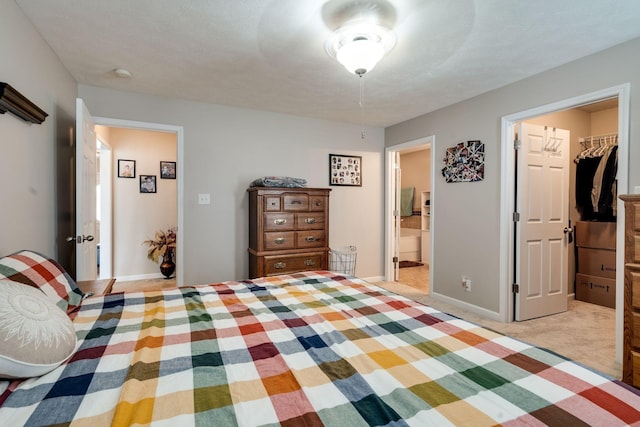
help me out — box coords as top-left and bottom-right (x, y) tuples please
(15, 0), (640, 127)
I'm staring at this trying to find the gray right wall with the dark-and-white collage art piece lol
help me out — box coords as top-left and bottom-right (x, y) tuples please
(385, 39), (640, 312)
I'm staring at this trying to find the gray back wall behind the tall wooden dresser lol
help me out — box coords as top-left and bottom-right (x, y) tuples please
(79, 85), (384, 284)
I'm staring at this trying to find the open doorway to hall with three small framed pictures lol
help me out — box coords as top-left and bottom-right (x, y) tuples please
(94, 117), (183, 285)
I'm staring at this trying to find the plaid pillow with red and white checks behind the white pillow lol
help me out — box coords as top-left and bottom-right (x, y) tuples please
(0, 250), (84, 314)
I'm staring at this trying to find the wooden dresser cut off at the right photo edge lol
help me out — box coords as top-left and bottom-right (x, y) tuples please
(620, 195), (640, 387)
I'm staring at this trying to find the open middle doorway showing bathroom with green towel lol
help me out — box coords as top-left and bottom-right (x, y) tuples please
(385, 137), (433, 293)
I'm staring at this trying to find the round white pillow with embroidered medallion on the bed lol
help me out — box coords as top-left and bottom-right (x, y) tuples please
(0, 280), (77, 378)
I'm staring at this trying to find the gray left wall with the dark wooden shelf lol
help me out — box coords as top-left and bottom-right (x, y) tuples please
(0, 1), (77, 256)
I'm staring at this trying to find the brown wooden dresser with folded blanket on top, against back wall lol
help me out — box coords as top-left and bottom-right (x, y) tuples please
(247, 187), (331, 279)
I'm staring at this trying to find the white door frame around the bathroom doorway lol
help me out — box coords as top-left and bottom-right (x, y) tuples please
(384, 135), (436, 282)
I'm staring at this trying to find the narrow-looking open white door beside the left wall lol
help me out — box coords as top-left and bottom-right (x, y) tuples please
(75, 98), (98, 280)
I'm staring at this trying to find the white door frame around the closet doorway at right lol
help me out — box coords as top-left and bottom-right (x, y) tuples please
(500, 83), (631, 363)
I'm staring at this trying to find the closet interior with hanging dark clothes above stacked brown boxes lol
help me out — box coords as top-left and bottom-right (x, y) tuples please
(527, 98), (618, 307)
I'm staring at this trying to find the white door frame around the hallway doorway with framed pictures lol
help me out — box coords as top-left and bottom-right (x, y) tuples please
(93, 116), (184, 286)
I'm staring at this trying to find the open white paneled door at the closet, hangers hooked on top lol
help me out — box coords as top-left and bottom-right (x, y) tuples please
(514, 123), (570, 320)
